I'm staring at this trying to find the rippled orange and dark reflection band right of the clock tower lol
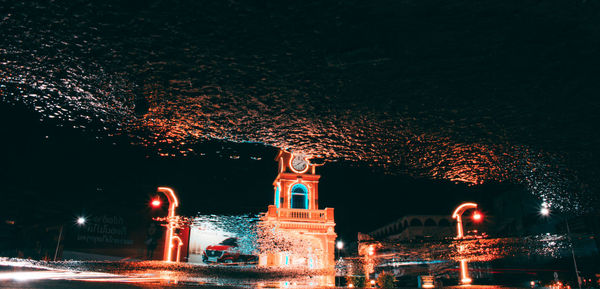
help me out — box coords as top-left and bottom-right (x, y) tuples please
(352, 234), (569, 278)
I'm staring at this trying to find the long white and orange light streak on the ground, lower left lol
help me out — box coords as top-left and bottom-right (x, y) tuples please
(0, 258), (333, 288)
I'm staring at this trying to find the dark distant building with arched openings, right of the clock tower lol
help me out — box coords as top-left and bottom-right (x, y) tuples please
(369, 215), (456, 241)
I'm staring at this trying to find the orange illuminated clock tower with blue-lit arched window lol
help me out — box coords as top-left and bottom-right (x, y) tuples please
(259, 151), (337, 270)
